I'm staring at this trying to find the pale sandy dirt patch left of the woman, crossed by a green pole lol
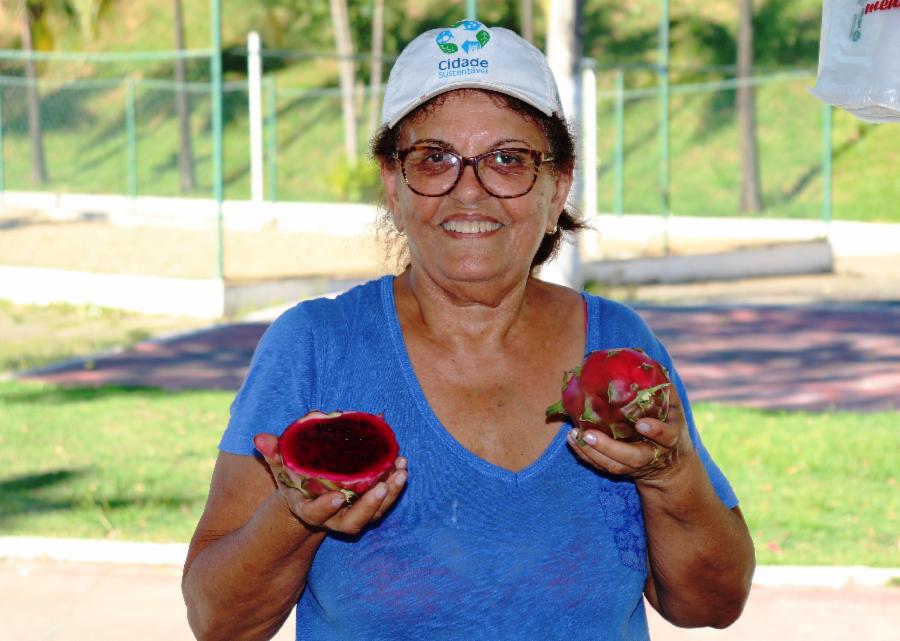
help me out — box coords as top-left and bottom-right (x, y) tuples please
(0, 212), (387, 281)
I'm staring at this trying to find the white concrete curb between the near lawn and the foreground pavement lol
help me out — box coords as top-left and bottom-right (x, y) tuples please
(0, 536), (900, 589)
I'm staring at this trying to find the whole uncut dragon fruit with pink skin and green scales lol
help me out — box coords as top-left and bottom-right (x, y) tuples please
(547, 348), (672, 441)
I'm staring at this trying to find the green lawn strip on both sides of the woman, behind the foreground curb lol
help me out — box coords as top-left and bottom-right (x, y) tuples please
(0, 382), (900, 567)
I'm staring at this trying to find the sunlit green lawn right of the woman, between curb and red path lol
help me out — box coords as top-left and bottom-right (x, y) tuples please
(695, 404), (900, 567)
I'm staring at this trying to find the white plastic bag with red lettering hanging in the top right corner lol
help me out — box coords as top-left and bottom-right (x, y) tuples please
(812, 0), (900, 122)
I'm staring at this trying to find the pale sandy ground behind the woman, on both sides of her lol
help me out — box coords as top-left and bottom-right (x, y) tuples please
(0, 208), (900, 304)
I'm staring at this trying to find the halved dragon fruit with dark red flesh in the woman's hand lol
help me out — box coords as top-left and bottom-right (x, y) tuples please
(278, 412), (400, 503)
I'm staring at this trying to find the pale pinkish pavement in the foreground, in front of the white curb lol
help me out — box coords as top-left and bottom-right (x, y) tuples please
(0, 560), (900, 641)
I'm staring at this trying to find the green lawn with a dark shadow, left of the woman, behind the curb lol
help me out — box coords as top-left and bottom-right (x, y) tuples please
(0, 382), (231, 541)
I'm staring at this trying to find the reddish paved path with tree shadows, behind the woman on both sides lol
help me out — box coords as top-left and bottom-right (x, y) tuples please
(22, 303), (900, 410)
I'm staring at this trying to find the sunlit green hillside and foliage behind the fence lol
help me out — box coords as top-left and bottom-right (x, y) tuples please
(0, 0), (900, 221)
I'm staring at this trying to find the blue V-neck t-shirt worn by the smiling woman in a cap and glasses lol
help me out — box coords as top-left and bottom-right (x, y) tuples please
(220, 276), (737, 641)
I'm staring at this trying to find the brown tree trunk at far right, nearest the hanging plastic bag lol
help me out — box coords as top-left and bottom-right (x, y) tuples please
(737, 0), (764, 213)
